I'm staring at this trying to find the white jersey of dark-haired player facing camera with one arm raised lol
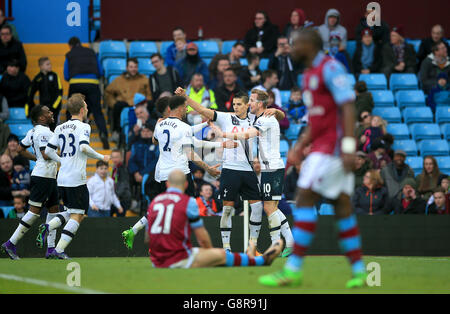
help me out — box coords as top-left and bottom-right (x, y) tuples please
(214, 111), (254, 171)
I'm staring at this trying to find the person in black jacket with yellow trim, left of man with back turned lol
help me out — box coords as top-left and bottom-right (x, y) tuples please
(25, 57), (63, 130)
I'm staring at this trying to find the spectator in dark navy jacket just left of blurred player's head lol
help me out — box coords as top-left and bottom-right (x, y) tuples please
(269, 36), (299, 90)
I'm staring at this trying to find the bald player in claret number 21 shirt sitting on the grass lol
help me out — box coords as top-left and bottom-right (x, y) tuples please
(147, 170), (283, 268)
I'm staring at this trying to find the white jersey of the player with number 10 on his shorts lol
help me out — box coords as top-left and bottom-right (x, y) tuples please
(253, 116), (284, 171)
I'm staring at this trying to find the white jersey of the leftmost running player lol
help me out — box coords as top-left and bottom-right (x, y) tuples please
(21, 124), (58, 179)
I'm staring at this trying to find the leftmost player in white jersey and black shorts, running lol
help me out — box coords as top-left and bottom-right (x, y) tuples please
(2, 105), (62, 260)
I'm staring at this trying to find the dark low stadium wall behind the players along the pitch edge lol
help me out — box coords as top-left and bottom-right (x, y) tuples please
(0, 216), (450, 258)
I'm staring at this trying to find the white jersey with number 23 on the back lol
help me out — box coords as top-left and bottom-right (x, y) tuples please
(48, 119), (91, 187)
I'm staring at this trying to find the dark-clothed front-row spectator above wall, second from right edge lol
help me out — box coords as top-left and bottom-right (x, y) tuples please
(389, 178), (427, 215)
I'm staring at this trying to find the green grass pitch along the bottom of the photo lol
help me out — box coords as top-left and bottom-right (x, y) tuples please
(0, 256), (450, 294)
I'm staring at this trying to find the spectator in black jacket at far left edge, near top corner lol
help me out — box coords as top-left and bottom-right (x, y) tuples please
(0, 24), (27, 73)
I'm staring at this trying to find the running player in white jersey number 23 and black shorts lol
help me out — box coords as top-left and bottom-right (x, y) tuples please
(38, 94), (110, 259)
